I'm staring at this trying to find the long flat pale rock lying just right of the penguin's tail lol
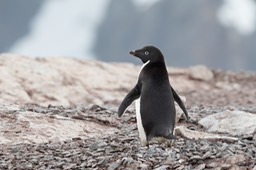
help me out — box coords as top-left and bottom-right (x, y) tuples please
(174, 126), (238, 142)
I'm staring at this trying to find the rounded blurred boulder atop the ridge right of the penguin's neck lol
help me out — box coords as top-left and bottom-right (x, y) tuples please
(189, 65), (214, 81)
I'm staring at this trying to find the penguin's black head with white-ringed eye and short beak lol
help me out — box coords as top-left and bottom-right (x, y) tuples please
(130, 46), (164, 63)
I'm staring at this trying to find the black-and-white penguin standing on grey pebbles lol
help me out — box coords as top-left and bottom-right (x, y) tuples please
(118, 46), (189, 146)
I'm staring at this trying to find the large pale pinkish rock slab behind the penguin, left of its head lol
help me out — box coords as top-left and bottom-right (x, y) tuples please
(0, 54), (139, 106)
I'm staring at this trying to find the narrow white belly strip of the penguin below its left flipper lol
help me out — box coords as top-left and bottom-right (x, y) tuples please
(135, 98), (147, 146)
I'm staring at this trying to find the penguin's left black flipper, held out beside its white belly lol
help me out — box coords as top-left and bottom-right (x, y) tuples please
(117, 82), (141, 117)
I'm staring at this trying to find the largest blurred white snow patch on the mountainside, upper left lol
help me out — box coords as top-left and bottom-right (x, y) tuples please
(10, 0), (109, 59)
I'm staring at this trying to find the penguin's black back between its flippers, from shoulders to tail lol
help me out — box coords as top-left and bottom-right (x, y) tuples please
(140, 71), (176, 138)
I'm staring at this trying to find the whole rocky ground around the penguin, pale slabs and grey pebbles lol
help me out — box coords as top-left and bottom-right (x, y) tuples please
(0, 55), (256, 170)
